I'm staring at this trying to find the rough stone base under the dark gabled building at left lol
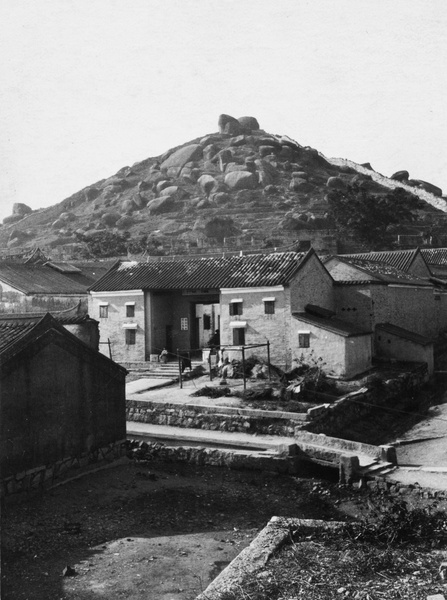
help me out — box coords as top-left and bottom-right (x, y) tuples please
(0, 440), (127, 498)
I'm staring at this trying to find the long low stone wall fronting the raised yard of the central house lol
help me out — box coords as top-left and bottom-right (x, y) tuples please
(126, 400), (307, 436)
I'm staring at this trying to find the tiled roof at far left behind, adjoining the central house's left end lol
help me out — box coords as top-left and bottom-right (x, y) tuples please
(0, 261), (114, 294)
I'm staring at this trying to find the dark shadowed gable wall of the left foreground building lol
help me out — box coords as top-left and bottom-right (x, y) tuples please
(0, 334), (126, 478)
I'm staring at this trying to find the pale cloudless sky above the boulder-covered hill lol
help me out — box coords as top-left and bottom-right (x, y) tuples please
(0, 0), (447, 220)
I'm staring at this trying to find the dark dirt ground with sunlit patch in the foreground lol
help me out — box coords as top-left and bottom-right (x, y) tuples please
(2, 462), (410, 600)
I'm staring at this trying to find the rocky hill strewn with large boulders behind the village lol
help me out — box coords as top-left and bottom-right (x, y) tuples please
(0, 115), (447, 257)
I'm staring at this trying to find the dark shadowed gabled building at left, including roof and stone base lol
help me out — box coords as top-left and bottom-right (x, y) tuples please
(0, 313), (127, 493)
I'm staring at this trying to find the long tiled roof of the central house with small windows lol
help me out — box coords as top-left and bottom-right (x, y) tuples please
(90, 250), (314, 292)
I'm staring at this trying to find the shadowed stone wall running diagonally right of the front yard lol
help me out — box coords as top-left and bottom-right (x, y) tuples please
(303, 365), (428, 437)
